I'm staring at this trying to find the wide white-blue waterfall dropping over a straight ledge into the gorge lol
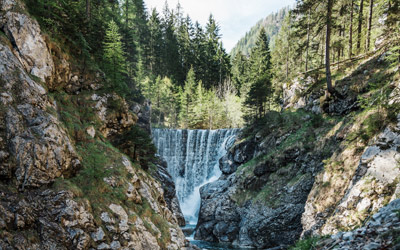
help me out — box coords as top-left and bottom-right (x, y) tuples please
(152, 129), (239, 224)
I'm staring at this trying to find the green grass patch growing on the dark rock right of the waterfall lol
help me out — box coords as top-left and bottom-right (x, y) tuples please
(233, 110), (338, 207)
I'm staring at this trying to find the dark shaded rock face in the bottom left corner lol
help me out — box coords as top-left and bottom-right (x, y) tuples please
(0, 189), (95, 249)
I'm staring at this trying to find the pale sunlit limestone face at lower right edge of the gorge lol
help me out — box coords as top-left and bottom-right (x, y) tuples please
(302, 116), (400, 235)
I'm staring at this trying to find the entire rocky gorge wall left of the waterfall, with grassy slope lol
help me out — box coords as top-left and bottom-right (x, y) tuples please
(0, 0), (194, 250)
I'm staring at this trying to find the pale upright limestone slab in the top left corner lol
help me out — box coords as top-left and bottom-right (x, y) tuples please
(0, 0), (54, 82)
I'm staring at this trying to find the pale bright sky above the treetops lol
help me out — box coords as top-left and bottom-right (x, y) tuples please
(144, 0), (296, 52)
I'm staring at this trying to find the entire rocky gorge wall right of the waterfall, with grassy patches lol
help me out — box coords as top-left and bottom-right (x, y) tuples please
(195, 50), (400, 249)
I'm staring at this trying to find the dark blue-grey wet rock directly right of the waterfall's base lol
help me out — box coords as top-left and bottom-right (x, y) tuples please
(194, 128), (318, 249)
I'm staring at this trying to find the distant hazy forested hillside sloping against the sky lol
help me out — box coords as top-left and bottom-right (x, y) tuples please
(230, 7), (290, 58)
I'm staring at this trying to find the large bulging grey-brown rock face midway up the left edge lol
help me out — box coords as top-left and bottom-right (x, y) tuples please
(0, 40), (80, 188)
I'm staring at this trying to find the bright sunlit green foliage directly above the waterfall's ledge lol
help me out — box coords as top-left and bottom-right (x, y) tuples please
(140, 68), (243, 129)
